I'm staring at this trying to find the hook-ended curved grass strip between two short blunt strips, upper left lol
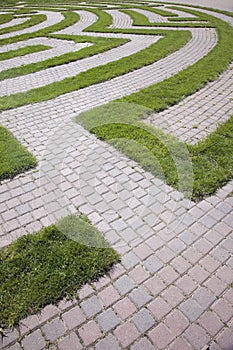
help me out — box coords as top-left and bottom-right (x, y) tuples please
(0, 11), (80, 45)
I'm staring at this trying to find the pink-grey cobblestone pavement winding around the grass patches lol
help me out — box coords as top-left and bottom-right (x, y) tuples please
(0, 2), (233, 350)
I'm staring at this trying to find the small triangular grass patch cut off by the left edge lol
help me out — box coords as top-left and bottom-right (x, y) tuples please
(0, 126), (37, 181)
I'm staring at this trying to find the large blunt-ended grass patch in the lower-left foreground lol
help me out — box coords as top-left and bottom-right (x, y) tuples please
(0, 215), (119, 329)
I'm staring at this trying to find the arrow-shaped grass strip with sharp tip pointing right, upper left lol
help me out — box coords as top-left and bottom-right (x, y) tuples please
(0, 34), (128, 81)
